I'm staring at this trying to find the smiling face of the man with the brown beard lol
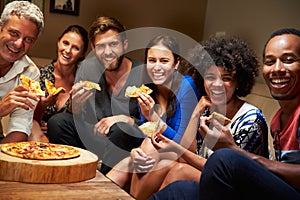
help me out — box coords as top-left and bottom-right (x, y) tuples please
(93, 30), (127, 71)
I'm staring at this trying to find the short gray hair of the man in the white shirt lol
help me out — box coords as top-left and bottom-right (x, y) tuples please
(1, 1), (44, 35)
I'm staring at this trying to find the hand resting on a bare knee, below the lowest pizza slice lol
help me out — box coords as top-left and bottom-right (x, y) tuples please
(130, 148), (155, 173)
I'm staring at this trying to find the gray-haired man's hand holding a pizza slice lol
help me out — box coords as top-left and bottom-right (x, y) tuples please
(0, 85), (39, 117)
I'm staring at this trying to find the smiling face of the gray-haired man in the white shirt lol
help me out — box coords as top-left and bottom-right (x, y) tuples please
(0, 15), (39, 66)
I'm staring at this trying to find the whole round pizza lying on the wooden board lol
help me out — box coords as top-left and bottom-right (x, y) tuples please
(1, 142), (80, 160)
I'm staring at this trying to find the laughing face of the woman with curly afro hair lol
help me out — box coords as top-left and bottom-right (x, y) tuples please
(204, 66), (237, 106)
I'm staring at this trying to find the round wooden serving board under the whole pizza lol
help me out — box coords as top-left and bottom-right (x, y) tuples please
(0, 145), (98, 183)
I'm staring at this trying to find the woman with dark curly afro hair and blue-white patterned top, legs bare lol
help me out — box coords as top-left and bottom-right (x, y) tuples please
(131, 36), (268, 199)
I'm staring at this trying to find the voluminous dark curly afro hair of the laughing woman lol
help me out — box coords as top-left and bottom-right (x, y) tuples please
(187, 35), (259, 97)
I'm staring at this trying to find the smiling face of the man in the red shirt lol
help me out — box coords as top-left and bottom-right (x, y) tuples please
(263, 34), (300, 100)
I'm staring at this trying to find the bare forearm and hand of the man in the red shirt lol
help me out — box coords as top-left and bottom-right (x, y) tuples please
(200, 117), (300, 190)
